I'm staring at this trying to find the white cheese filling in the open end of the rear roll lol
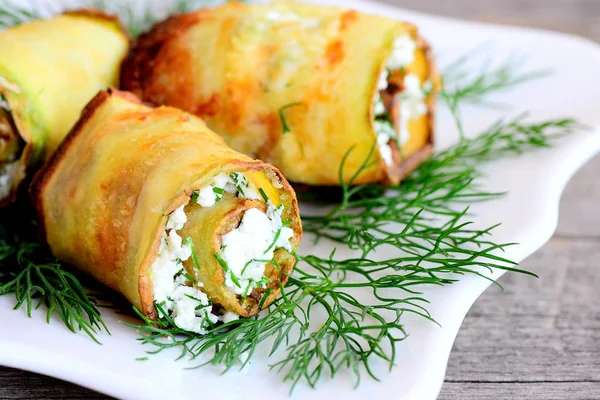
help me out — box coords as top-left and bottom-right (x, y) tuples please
(374, 34), (427, 165)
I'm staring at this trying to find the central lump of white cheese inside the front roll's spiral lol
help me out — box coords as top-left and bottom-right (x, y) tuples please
(221, 201), (294, 295)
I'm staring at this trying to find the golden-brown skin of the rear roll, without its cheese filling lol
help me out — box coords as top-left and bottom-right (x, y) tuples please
(121, 2), (435, 186)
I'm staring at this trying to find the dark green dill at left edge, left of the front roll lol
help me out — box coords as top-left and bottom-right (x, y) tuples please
(0, 219), (109, 343)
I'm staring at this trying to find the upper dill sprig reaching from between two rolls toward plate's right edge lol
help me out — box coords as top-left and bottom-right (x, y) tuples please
(302, 115), (579, 242)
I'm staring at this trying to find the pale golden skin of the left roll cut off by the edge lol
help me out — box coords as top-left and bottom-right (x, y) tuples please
(5, 12), (129, 207)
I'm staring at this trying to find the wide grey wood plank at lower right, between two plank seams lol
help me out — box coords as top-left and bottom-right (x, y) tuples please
(442, 239), (600, 388)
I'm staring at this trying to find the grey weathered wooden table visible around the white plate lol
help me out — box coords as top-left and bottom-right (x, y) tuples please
(0, 0), (600, 400)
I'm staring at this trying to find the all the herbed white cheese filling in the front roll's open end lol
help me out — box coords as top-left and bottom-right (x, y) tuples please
(152, 173), (294, 334)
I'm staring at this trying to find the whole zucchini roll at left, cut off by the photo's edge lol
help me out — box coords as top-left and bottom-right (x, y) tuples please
(0, 10), (129, 205)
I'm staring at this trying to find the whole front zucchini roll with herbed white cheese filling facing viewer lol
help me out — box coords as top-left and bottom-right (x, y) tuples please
(32, 90), (302, 333)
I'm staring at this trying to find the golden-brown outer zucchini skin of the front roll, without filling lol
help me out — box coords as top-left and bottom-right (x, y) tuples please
(30, 89), (302, 319)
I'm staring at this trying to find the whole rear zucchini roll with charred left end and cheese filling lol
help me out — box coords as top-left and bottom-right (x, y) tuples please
(121, 2), (438, 186)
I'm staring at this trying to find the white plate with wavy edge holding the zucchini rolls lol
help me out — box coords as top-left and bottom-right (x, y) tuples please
(0, 0), (600, 400)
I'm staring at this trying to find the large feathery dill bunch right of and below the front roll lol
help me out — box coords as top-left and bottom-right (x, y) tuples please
(127, 117), (577, 389)
